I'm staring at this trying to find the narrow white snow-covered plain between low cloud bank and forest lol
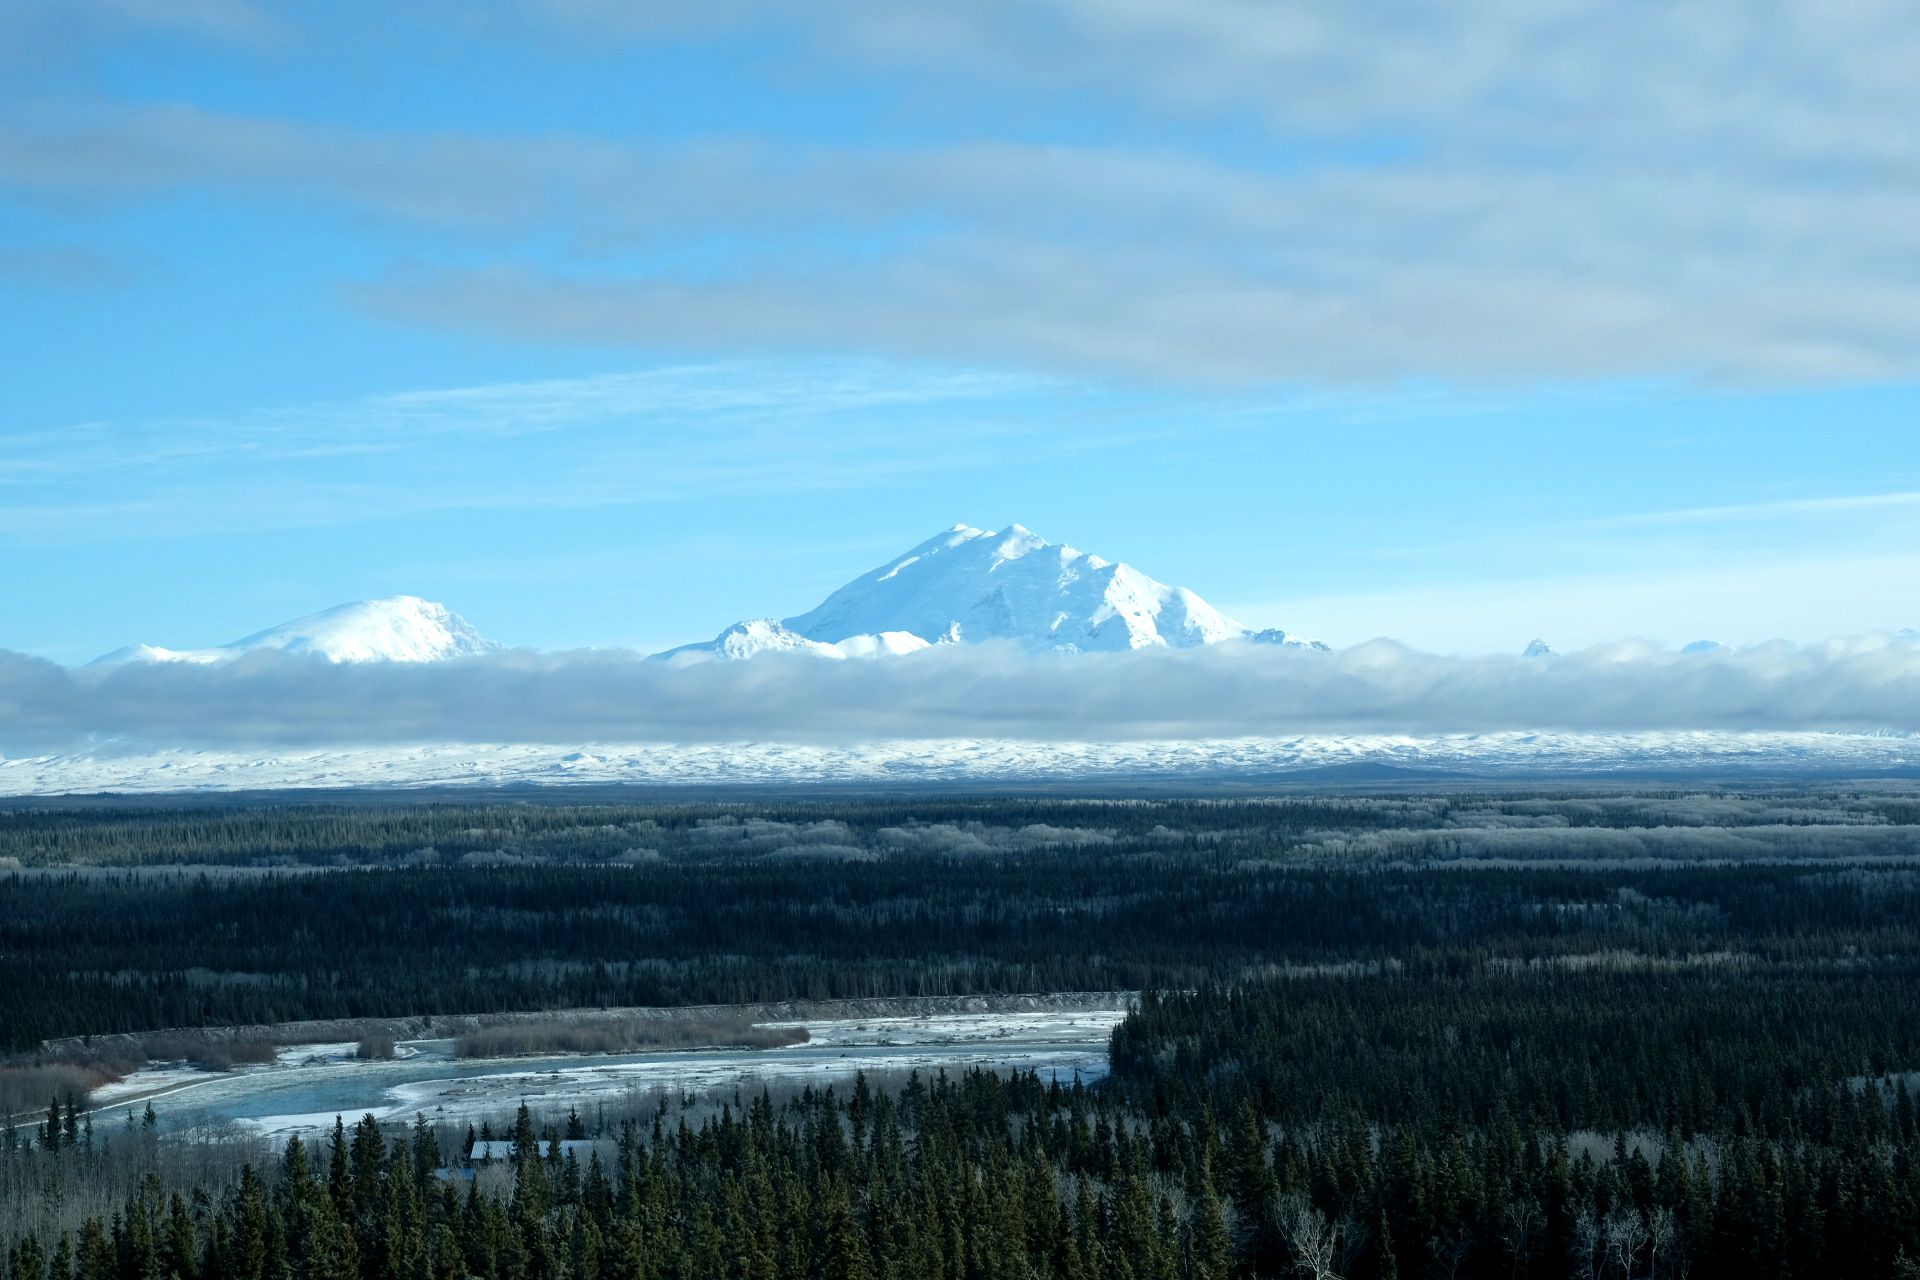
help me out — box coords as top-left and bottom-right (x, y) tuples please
(0, 731), (1920, 796)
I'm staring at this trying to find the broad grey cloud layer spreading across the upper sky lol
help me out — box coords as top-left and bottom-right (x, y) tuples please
(11, 0), (1920, 382)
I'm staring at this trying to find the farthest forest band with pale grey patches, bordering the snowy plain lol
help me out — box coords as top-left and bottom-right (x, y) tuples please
(0, 789), (1920, 867)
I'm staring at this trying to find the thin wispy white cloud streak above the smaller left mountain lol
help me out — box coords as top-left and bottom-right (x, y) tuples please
(0, 361), (1082, 545)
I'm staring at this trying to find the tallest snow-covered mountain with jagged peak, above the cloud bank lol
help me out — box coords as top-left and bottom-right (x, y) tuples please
(662, 524), (1325, 658)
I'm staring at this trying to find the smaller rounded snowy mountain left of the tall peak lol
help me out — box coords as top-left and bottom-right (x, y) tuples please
(92, 595), (499, 666)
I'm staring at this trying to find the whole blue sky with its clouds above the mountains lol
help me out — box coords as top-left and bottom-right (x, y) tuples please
(0, 0), (1920, 662)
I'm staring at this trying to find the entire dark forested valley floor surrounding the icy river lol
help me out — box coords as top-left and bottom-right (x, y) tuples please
(0, 789), (1920, 1280)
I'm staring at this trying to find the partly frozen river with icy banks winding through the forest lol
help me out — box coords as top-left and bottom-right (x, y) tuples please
(94, 1009), (1123, 1136)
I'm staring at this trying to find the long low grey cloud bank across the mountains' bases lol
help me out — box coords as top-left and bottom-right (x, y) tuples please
(0, 637), (1920, 756)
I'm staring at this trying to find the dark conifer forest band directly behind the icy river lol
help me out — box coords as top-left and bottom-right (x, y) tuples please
(0, 848), (1920, 1052)
